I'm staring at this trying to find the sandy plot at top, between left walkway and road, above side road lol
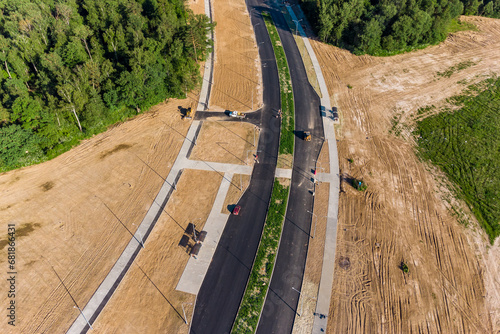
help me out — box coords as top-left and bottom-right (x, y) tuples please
(209, 0), (262, 111)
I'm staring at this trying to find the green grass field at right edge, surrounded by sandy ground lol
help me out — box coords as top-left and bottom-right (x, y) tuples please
(415, 77), (500, 243)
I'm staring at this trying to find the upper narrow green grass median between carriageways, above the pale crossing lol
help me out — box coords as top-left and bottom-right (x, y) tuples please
(262, 12), (295, 155)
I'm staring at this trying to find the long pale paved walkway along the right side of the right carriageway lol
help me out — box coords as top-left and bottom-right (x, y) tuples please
(286, 6), (340, 334)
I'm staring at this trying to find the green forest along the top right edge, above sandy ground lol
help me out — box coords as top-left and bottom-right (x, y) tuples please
(301, 0), (500, 56)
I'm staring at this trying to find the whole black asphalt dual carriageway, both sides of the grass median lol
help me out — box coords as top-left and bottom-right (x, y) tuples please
(191, 0), (323, 334)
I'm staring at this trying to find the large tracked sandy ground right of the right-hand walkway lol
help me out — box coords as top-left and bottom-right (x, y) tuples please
(313, 17), (500, 333)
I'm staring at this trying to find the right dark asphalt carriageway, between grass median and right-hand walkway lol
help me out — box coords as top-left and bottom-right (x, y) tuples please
(257, 5), (323, 334)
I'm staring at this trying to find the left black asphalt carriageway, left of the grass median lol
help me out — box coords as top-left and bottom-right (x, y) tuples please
(190, 0), (286, 334)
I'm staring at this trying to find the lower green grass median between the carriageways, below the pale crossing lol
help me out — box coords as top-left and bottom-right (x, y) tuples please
(232, 179), (289, 334)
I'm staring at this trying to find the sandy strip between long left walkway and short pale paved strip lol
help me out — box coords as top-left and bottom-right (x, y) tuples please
(94, 170), (222, 333)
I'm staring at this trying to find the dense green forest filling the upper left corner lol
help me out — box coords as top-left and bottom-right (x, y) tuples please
(0, 0), (213, 172)
